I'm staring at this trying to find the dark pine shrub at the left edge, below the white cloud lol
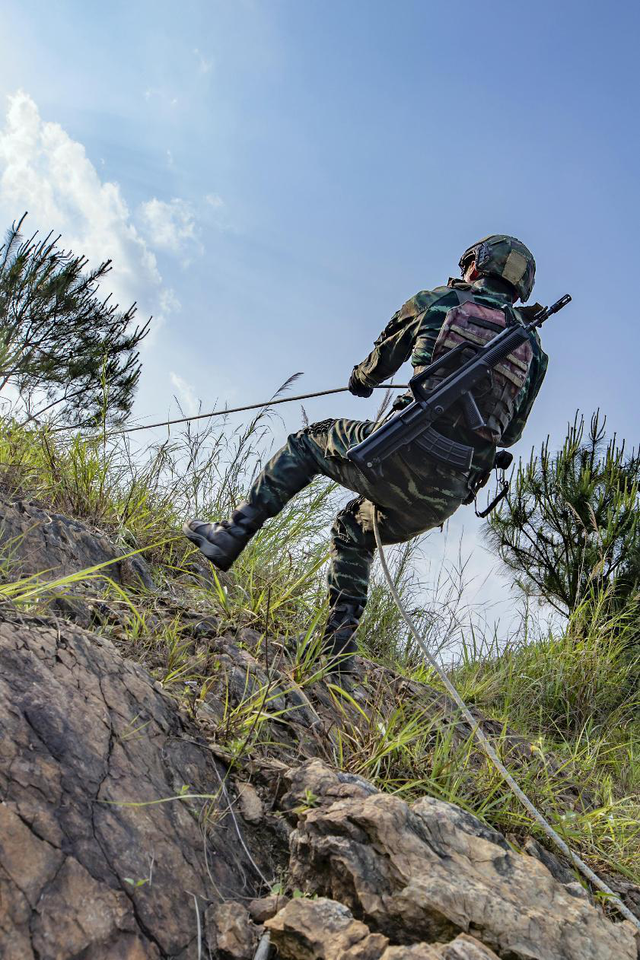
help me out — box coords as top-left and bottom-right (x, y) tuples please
(0, 214), (149, 425)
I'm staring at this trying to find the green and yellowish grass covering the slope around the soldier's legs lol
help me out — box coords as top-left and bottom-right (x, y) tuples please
(0, 413), (640, 882)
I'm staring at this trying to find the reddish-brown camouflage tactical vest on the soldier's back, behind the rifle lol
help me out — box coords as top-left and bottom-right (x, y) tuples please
(428, 291), (533, 444)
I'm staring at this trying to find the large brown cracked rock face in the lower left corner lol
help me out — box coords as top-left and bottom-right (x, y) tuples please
(0, 611), (269, 960)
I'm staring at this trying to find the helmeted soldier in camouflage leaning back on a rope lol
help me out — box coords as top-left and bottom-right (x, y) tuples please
(183, 235), (547, 672)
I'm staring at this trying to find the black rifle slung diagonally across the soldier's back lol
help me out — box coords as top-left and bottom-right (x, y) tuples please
(347, 293), (571, 480)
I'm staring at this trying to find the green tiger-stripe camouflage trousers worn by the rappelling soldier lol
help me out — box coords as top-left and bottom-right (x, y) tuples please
(248, 420), (469, 606)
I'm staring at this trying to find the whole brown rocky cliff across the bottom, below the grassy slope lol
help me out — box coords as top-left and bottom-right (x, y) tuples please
(0, 501), (640, 960)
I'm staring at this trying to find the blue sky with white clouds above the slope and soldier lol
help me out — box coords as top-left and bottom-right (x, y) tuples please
(0, 0), (640, 624)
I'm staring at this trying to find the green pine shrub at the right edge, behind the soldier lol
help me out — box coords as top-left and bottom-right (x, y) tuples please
(487, 413), (640, 613)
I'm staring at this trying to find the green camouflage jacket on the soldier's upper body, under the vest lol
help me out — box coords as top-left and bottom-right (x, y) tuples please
(354, 277), (549, 469)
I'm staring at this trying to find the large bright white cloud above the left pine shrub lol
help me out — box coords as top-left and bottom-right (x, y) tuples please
(0, 91), (178, 343)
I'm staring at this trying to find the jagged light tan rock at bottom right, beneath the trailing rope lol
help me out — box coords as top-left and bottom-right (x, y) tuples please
(291, 761), (636, 960)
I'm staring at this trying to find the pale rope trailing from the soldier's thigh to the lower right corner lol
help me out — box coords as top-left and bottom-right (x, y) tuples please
(373, 510), (640, 930)
